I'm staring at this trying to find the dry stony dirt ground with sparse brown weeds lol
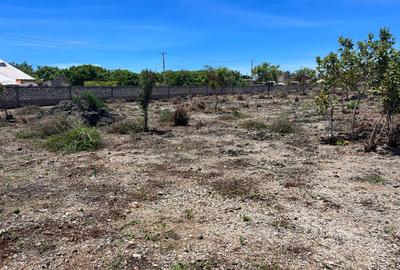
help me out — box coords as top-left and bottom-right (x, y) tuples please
(0, 94), (400, 270)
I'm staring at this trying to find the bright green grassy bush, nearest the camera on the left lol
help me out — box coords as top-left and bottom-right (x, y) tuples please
(46, 127), (102, 152)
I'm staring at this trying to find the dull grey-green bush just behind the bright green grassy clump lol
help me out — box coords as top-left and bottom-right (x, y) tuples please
(17, 116), (73, 139)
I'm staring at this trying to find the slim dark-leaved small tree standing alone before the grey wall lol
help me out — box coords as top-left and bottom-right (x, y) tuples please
(139, 70), (157, 132)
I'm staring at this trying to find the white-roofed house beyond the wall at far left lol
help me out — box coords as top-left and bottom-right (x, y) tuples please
(0, 59), (37, 86)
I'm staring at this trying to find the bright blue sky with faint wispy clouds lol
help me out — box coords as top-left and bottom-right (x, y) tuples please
(0, 0), (400, 73)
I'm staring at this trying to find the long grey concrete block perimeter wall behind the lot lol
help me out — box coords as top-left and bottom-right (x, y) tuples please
(0, 85), (298, 109)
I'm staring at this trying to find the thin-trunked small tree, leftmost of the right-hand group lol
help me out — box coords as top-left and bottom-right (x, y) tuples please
(317, 53), (340, 142)
